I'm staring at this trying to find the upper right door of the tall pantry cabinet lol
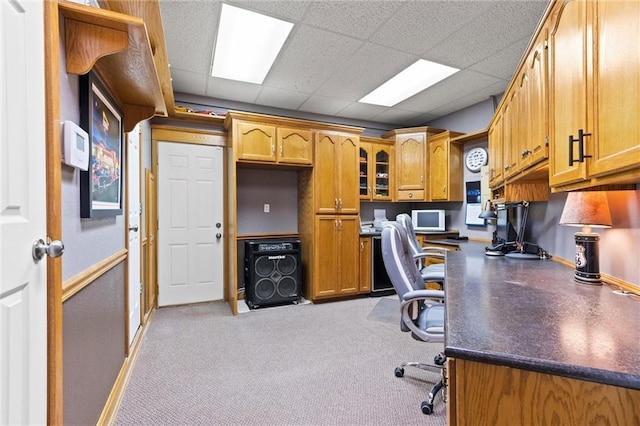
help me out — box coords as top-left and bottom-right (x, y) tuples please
(335, 136), (360, 214)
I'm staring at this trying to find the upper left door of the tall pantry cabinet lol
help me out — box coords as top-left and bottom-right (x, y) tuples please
(313, 132), (338, 214)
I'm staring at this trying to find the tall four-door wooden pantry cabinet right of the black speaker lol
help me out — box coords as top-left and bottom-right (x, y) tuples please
(298, 127), (362, 300)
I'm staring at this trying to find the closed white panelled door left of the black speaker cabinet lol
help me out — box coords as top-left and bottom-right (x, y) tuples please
(158, 142), (225, 306)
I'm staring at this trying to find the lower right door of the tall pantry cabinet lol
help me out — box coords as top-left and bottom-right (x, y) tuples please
(336, 215), (360, 294)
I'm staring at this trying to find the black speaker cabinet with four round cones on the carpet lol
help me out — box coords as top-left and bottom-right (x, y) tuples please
(244, 239), (302, 309)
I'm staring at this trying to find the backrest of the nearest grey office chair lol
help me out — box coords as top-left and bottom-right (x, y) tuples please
(381, 222), (424, 300)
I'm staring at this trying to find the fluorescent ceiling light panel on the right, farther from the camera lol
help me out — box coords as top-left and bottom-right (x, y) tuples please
(359, 59), (460, 107)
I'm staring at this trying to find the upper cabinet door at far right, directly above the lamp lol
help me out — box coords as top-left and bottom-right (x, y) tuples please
(588, 1), (640, 176)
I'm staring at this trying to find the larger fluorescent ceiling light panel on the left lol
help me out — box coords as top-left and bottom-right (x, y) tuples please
(211, 3), (293, 84)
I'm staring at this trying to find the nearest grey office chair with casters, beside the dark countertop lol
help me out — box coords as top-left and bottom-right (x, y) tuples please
(381, 222), (446, 414)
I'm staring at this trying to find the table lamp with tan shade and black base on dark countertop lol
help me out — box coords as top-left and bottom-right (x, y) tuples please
(560, 191), (611, 285)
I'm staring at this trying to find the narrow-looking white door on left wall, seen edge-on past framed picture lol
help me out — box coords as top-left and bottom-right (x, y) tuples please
(127, 125), (142, 345)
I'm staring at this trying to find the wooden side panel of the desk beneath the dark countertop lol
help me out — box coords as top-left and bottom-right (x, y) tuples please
(447, 358), (640, 426)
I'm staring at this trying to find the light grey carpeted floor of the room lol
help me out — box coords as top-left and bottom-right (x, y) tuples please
(115, 296), (446, 425)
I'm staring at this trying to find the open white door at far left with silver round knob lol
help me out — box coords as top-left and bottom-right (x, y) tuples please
(0, 0), (47, 425)
